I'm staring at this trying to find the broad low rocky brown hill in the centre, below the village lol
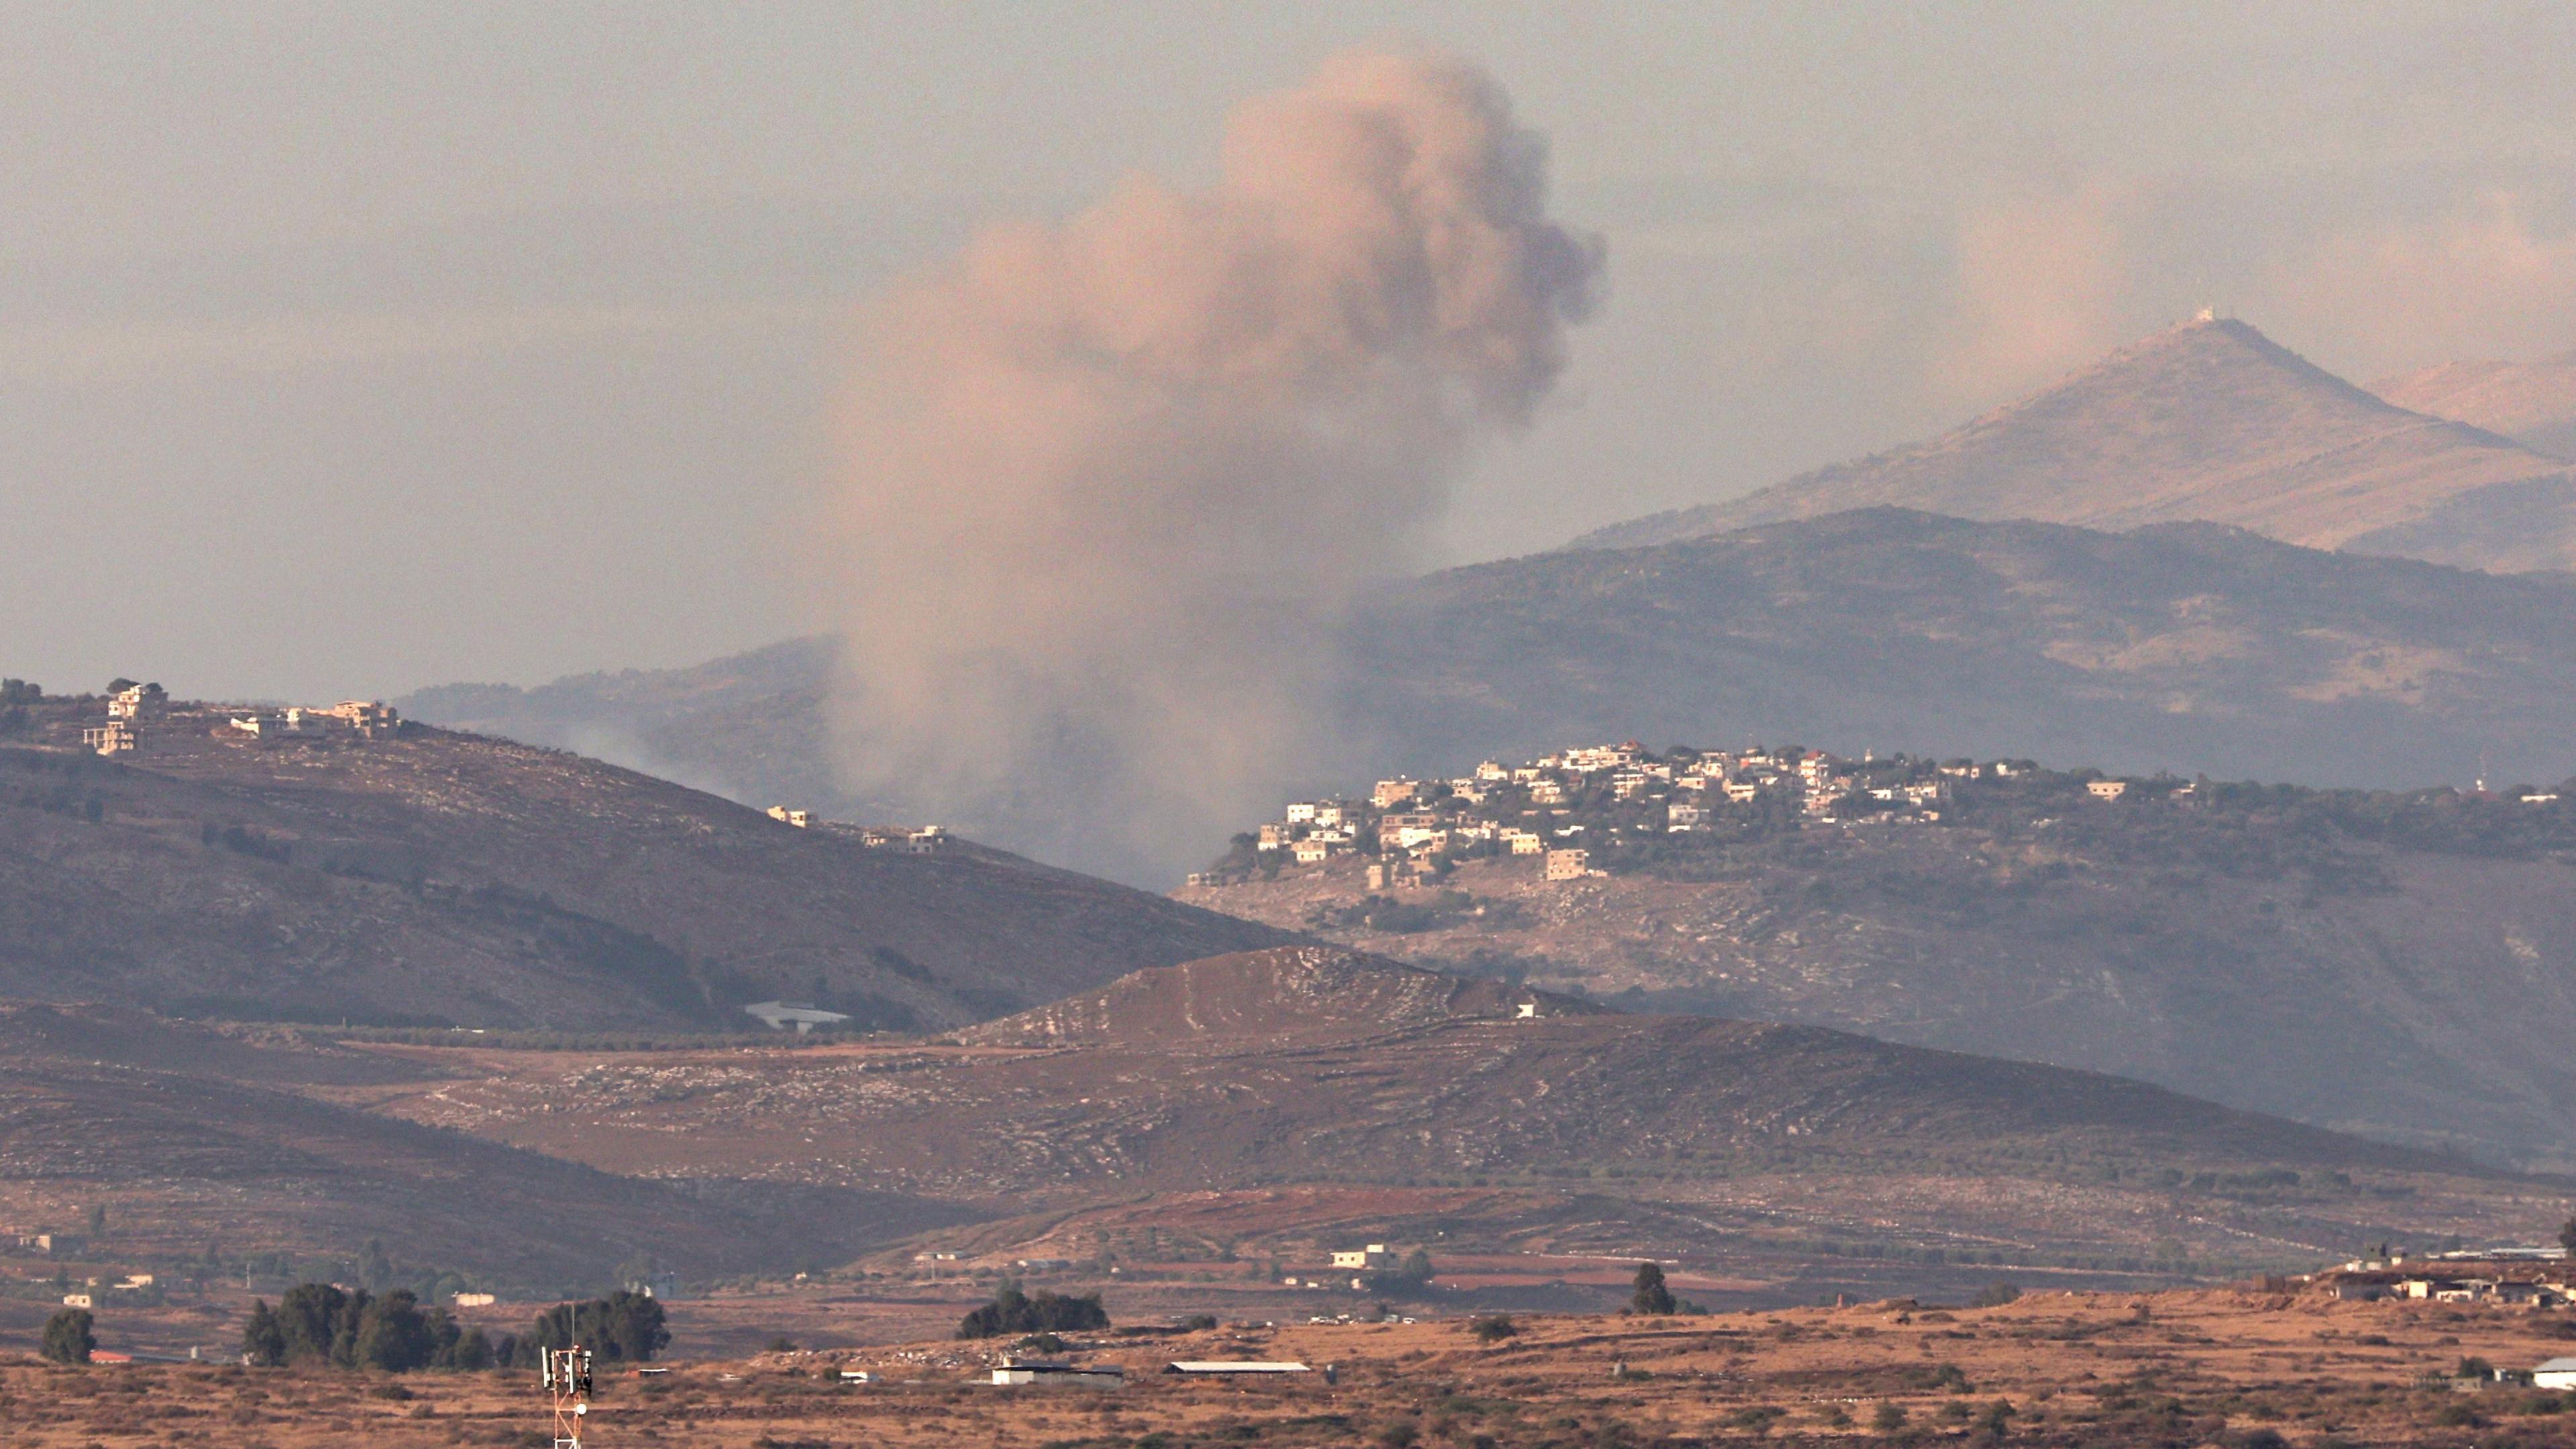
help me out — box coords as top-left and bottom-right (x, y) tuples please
(376, 951), (2563, 1271)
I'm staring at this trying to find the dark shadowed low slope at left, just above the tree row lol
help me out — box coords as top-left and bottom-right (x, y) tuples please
(0, 1006), (958, 1292)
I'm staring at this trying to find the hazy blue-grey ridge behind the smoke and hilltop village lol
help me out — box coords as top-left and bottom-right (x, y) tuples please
(412, 511), (2576, 835)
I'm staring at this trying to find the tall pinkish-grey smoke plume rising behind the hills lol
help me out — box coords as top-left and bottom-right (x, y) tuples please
(837, 52), (1600, 879)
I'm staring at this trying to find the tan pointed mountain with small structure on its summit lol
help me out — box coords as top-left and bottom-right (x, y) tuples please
(1574, 317), (2576, 572)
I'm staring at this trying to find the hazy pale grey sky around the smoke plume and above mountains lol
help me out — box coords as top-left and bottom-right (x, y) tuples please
(0, 0), (2576, 699)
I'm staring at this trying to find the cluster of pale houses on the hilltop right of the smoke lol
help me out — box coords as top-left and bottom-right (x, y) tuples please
(1190, 740), (2081, 890)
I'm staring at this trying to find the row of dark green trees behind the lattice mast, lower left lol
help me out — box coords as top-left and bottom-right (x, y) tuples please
(242, 1284), (669, 1375)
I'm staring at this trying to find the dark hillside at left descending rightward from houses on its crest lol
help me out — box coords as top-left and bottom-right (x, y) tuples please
(0, 699), (1283, 1031)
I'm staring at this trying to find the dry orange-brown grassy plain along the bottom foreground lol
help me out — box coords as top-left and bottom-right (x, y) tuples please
(15, 1292), (2571, 1449)
